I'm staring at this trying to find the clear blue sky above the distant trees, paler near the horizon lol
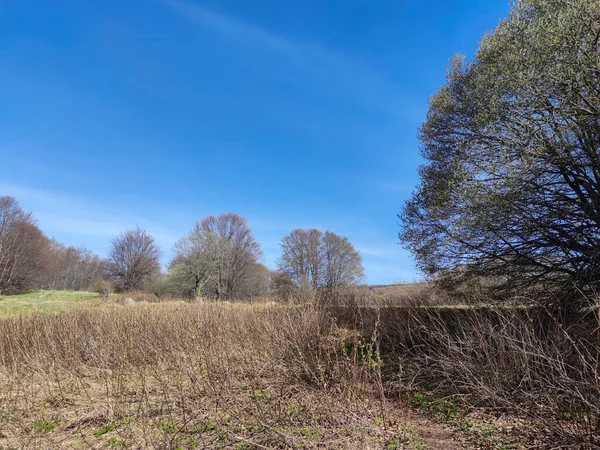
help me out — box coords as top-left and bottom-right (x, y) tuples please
(0, 0), (509, 283)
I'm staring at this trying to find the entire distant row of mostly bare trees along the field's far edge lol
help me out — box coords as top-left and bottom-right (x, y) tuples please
(0, 196), (363, 300)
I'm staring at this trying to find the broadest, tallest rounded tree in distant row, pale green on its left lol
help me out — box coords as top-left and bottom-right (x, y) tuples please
(171, 213), (262, 299)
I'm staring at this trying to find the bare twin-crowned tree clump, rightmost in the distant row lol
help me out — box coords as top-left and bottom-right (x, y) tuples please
(278, 228), (364, 293)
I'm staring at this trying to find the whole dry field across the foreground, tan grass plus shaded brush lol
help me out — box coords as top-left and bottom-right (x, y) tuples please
(0, 290), (600, 449)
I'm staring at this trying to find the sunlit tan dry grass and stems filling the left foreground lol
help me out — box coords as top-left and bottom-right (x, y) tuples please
(0, 302), (385, 449)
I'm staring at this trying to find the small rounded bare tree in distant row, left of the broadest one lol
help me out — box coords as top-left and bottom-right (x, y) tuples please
(107, 227), (161, 291)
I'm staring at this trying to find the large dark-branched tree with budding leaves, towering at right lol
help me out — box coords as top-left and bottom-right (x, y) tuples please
(399, 0), (600, 304)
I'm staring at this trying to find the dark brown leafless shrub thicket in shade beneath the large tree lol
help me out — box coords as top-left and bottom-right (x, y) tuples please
(336, 300), (600, 448)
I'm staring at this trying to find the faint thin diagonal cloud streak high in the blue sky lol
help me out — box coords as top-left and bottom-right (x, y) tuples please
(159, 0), (423, 123)
